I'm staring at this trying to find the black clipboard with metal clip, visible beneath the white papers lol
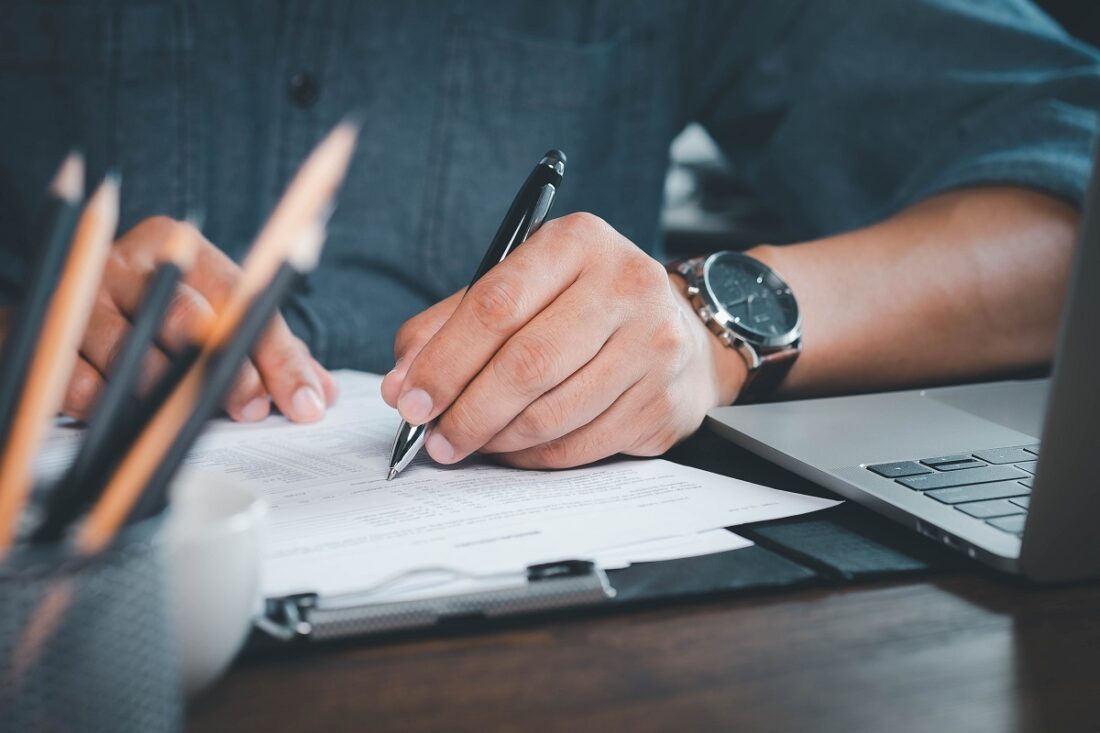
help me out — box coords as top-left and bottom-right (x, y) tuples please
(252, 503), (965, 647)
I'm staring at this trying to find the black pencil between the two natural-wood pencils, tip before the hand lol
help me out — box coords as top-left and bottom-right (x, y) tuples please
(30, 221), (198, 543)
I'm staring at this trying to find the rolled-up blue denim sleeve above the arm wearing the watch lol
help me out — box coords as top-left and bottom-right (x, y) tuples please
(685, 0), (1100, 239)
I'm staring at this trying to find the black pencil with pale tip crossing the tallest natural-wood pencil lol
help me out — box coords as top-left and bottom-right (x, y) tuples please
(127, 226), (325, 523)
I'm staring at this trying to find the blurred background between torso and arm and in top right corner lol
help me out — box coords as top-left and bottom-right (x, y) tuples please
(663, 0), (1100, 259)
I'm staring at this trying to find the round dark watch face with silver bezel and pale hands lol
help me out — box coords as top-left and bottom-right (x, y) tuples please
(704, 252), (799, 346)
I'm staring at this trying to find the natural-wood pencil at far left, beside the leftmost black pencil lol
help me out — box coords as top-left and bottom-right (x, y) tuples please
(0, 174), (119, 556)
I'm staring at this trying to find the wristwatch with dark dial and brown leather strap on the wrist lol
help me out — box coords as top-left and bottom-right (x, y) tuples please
(668, 251), (802, 401)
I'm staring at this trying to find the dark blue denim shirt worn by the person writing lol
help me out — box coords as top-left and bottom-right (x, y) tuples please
(0, 0), (1100, 371)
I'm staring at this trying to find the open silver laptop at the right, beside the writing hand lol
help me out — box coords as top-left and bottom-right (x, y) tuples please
(707, 148), (1100, 582)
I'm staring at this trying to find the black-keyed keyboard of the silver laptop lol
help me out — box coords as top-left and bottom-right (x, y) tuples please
(867, 445), (1038, 536)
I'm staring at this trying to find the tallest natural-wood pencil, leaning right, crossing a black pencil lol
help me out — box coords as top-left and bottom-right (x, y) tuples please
(76, 122), (358, 554)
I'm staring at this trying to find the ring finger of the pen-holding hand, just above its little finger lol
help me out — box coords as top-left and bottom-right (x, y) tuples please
(479, 331), (645, 453)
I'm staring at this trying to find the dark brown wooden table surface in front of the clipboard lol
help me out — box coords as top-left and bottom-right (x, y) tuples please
(188, 431), (1100, 733)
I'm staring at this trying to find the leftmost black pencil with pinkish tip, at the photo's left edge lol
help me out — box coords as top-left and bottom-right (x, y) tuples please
(0, 153), (84, 457)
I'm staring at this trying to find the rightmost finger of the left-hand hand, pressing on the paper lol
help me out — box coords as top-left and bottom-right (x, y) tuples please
(253, 316), (326, 423)
